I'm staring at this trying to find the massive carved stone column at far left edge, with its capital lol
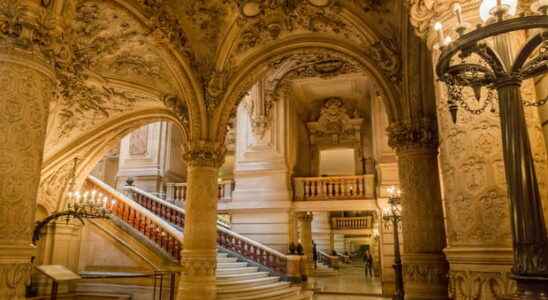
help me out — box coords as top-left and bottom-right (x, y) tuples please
(0, 0), (55, 300)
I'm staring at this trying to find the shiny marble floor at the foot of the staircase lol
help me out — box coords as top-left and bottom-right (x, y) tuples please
(308, 262), (382, 300)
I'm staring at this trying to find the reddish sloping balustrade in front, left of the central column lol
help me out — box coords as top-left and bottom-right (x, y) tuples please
(84, 176), (183, 260)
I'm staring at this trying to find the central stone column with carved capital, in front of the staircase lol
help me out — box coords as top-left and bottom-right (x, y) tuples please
(177, 144), (223, 300)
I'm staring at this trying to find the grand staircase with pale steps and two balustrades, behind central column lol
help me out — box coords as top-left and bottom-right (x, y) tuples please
(85, 176), (312, 300)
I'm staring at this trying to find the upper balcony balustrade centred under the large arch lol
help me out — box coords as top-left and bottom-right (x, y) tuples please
(294, 175), (375, 201)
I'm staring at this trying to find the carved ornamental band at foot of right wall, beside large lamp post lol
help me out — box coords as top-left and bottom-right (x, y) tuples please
(449, 270), (516, 300)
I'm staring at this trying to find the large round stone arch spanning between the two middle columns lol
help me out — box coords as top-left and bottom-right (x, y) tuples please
(209, 35), (402, 142)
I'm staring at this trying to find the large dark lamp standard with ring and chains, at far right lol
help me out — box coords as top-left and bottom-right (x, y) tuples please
(434, 0), (548, 299)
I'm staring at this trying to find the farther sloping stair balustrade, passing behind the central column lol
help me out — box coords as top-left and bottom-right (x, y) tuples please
(125, 182), (288, 274)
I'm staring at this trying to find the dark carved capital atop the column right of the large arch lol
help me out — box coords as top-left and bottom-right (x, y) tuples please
(386, 118), (438, 153)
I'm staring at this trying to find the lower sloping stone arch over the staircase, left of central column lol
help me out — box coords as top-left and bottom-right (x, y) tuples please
(37, 108), (184, 213)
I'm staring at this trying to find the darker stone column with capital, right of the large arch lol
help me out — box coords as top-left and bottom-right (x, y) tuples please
(388, 119), (449, 299)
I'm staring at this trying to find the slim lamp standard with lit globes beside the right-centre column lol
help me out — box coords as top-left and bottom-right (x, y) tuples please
(382, 186), (405, 300)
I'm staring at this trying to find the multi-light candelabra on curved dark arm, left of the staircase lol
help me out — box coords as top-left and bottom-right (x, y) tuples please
(32, 158), (116, 245)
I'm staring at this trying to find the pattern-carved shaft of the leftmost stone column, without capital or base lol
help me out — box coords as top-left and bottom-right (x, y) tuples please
(0, 61), (54, 240)
